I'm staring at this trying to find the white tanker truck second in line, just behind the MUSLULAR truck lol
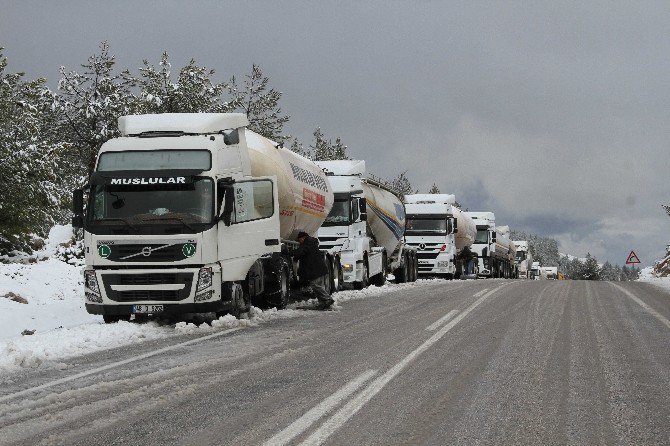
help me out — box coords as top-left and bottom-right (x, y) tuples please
(316, 160), (417, 289)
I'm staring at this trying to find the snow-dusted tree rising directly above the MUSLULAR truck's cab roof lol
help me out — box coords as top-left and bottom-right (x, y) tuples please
(136, 51), (232, 113)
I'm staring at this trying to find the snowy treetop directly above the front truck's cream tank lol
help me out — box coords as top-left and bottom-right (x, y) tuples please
(227, 64), (290, 143)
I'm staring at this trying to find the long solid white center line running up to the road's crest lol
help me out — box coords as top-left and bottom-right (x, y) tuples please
(300, 284), (505, 446)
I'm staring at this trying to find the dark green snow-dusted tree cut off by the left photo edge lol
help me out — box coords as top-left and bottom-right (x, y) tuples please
(0, 48), (65, 254)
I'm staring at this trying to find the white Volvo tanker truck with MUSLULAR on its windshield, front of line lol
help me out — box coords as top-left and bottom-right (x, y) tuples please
(73, 113), (342, 323)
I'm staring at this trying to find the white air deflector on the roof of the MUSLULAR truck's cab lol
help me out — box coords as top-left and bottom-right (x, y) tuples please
(119, 113), (249, 136)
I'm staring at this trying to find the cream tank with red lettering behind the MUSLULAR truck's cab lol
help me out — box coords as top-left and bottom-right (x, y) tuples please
(245, 130), (333, 240)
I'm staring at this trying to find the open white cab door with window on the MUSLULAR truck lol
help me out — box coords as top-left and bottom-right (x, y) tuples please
(218, 176), (281, 281)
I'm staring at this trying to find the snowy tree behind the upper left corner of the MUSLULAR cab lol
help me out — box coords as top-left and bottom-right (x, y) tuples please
(54, 42), (138, 176)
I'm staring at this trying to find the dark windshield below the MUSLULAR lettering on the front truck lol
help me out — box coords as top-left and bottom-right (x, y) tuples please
(88, 178), (214, 229)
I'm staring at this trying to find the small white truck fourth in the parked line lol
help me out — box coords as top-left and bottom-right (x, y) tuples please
(465, 212), (516, 278)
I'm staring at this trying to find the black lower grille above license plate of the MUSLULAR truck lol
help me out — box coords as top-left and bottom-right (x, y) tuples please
(101, 273), (194, 302)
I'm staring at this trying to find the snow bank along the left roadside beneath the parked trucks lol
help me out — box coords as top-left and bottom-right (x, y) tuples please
(0, 233), (448, 373)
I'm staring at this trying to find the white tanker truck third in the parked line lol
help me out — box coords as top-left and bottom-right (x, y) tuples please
(405, 194), (477, 280)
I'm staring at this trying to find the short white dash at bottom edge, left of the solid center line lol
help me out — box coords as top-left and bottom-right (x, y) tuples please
(264, 370), (377, 446)
